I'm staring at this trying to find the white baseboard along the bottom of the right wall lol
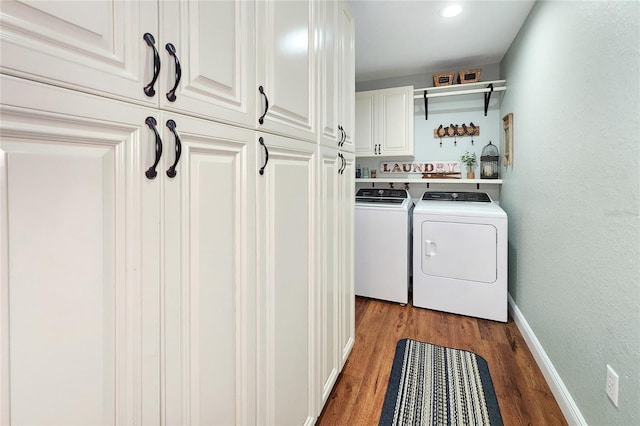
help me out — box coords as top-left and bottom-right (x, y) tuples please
(508, 294), (587, 426)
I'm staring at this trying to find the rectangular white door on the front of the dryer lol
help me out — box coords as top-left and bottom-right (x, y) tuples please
(421, 221), (497, 283)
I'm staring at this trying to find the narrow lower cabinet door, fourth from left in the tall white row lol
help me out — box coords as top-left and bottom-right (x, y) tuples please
(316, 147), (343, 411)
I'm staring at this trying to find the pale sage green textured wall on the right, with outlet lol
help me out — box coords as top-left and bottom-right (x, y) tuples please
(501, 1), (640, 425)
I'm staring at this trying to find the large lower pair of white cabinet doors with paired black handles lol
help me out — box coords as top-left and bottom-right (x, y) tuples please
(0, 77), (256, 424)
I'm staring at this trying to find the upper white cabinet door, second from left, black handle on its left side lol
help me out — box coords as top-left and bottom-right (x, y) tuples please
(158, 0), (258, 126)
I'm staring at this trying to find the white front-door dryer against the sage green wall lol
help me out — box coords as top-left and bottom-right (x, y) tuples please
(413, 191), (507, 322)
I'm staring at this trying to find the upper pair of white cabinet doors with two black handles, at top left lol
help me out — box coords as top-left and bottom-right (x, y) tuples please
(0, 0), (257, 127)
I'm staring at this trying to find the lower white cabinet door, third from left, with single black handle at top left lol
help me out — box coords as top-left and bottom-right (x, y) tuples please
(256, 134), (316, 425)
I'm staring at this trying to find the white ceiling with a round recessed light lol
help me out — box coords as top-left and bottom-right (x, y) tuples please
(349, 0), (534, 82)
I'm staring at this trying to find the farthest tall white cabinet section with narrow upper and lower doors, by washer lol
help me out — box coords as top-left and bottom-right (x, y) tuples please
(316, 2), (355, 412)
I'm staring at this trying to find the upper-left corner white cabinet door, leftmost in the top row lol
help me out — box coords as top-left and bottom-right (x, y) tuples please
(0, 0), (160, 105)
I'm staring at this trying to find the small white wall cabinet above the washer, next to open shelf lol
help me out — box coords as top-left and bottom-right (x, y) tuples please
(355, 86), (413, 157)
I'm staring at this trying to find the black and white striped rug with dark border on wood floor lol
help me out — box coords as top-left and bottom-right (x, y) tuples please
(379, 339), (502, 426)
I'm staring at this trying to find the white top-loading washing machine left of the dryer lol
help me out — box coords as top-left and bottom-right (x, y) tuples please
(354, 188), (413, 304)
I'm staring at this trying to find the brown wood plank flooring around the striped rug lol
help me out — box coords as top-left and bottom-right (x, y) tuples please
(317, 297), (567, 426)
